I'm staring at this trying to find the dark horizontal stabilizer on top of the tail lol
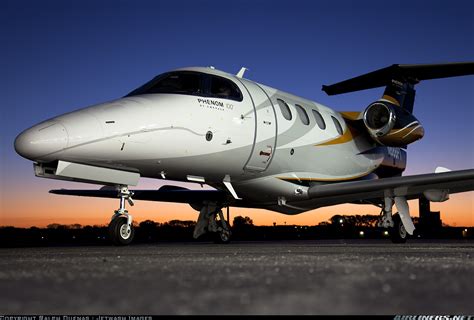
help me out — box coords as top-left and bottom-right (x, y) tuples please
(322, 62), (474, 96)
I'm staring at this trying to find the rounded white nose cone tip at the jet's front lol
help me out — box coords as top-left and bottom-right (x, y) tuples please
(15, 121), (68, 160)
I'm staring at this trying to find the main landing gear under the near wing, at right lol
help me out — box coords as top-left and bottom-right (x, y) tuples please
(377, 197), (415, 243)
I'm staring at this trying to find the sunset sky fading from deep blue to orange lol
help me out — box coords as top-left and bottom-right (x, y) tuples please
(0, 0), (474, 227)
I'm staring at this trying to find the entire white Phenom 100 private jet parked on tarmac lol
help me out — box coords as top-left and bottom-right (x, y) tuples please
(14, 62), (474, 245)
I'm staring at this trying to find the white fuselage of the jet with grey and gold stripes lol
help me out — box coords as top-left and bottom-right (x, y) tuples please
(16, 68), (396, 213)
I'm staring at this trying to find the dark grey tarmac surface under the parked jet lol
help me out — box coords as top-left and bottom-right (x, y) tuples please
(0, 240), (474, 315)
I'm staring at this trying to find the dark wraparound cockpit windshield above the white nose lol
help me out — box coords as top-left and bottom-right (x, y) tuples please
(127, 71), (243, 101)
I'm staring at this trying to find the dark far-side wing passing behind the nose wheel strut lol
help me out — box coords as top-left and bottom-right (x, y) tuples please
(49, 186), (227, 203)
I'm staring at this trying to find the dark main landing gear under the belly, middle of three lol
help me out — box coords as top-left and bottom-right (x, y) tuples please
(193, 203), (231, 243)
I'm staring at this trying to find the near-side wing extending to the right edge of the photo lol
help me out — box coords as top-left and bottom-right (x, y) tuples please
(308, 169), (474, 206)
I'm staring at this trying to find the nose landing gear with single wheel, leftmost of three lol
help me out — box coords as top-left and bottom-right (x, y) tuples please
(109, 186), (135, 246)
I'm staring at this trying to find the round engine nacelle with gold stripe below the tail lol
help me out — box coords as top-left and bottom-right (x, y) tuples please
(363, 100), (425, 147)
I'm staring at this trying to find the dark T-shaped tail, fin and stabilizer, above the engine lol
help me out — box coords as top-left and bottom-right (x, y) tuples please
(322, 62), (474, 113)
